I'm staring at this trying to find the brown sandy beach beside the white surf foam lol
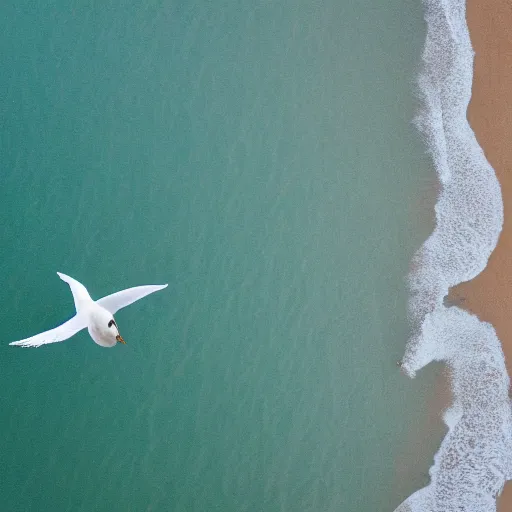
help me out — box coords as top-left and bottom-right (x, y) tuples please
(450, 0), (512, 506)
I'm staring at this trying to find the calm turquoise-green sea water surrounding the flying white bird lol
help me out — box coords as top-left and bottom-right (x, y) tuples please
(0, 0), (433, 512)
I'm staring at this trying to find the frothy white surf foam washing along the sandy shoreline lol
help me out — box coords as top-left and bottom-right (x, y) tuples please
(396, 0), (512, 512)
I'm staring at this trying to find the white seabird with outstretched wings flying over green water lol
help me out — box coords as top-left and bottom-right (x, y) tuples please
(9, 272), (167, 347)
